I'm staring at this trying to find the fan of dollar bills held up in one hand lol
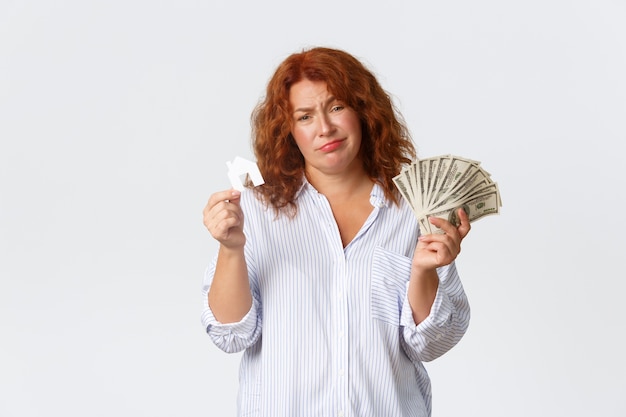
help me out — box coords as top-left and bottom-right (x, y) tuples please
(393, 155), (502, 234)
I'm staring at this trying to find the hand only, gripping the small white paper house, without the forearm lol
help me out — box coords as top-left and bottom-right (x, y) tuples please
(202, 189), (246, 249)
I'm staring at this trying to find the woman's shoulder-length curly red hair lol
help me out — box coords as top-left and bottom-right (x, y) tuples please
(251, 47), (416, 215)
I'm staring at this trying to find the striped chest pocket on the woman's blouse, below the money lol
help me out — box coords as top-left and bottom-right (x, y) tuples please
(370, 247), (411, 326)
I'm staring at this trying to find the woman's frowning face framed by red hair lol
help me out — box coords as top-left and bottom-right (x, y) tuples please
(289, 79), (361, 175)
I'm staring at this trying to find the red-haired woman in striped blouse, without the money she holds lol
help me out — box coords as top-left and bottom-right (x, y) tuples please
(202, 48), (470, 417)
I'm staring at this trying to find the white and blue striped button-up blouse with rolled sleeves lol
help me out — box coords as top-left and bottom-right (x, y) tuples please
(202, 182), (470, 417)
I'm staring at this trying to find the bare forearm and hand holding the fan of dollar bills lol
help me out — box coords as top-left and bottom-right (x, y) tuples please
(408, 209), (471, 324)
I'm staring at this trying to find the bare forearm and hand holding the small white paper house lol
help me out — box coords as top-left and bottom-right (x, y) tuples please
(203, 190), (252, 323)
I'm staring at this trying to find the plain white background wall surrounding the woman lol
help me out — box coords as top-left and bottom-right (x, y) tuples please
(0, 0), (626, 417)
